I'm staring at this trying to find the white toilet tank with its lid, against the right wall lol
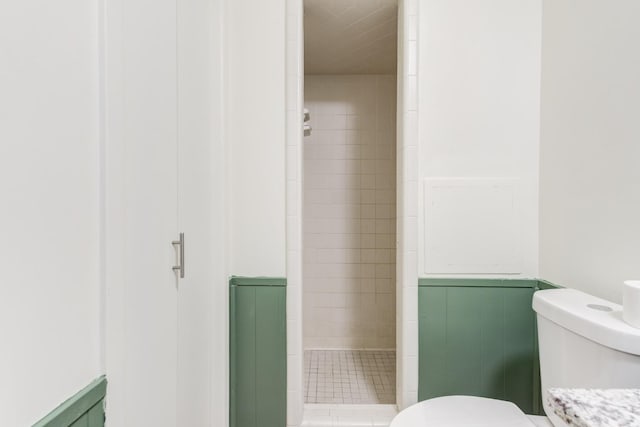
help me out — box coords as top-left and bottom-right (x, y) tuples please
(533, 289), (640, 426)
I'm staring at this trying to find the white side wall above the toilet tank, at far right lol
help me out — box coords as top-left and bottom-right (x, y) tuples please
(540, 0), (640, 302)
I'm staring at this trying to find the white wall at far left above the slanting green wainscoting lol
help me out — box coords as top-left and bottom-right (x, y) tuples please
(0, 0), (101, 426)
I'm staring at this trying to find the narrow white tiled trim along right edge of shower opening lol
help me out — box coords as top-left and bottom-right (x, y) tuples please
(396, 0), (419, 410)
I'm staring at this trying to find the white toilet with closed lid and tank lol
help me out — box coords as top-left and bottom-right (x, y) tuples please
(390, 289), (640, 427)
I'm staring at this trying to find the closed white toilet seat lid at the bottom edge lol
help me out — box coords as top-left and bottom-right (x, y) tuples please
(390, 396), (535, 427)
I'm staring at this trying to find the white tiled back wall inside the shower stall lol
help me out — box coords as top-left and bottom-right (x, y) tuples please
(303, 75), (396, 349)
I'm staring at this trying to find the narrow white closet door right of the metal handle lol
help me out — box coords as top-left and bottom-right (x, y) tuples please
(177, 0), (228, 427)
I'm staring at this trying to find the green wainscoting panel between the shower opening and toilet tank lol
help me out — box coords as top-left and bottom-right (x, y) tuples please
(418, 279), (537, 414)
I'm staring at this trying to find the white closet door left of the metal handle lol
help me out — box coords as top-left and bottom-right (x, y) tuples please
(105, 0), (178, 427)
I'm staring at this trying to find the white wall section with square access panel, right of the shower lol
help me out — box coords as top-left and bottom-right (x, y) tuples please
(418, 0), (541, 277)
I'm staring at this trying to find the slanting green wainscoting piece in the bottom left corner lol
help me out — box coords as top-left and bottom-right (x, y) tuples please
(33, 377), (107, 427)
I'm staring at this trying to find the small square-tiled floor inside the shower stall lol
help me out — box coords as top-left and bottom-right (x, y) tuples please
(304, 350), (396, 404)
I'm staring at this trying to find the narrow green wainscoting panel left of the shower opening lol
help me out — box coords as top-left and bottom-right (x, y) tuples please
(229, 277), (287, 427)
